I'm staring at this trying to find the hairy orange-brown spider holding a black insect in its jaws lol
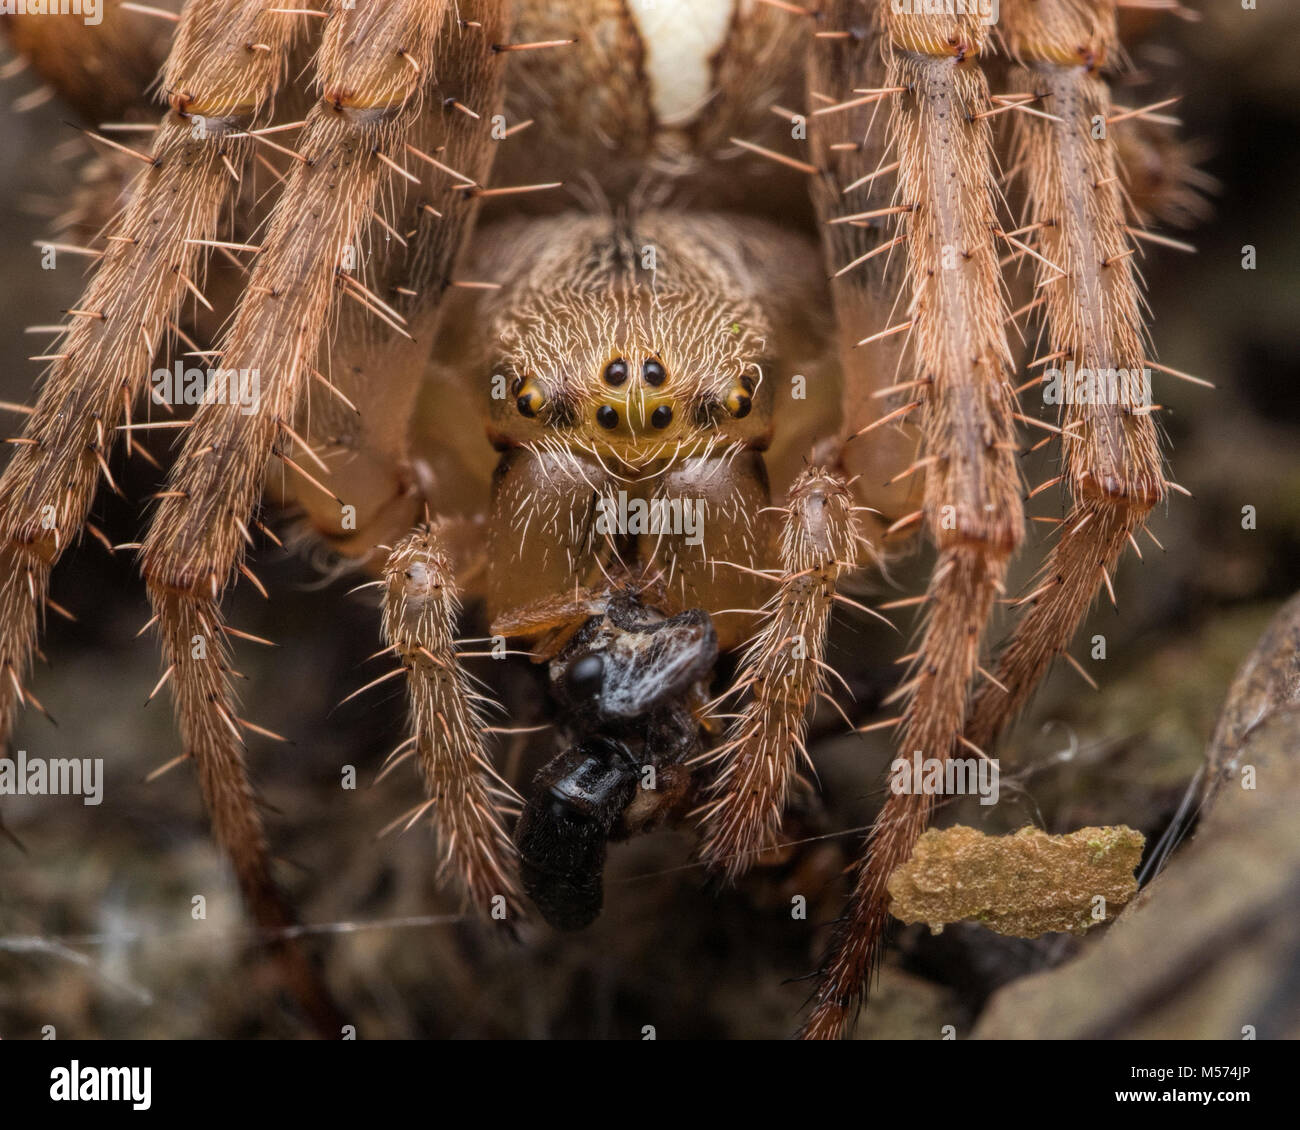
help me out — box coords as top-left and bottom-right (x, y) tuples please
(0, 0), (1201, 1038)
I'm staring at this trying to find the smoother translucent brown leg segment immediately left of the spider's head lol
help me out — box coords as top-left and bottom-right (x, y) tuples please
(289, 12), (527, 564)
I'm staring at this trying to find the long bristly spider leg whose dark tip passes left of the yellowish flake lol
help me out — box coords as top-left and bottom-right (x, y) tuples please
(802, 4), (1022, 1039)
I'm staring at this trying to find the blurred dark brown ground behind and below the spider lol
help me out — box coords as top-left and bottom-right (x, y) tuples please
(0, 0), (1300, 1039)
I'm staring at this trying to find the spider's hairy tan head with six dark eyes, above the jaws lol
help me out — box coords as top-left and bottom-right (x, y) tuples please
(490, 213), (771, 464)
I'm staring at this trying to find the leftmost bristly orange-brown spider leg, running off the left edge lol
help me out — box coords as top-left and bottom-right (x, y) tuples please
(0, 0), (295, 741)
